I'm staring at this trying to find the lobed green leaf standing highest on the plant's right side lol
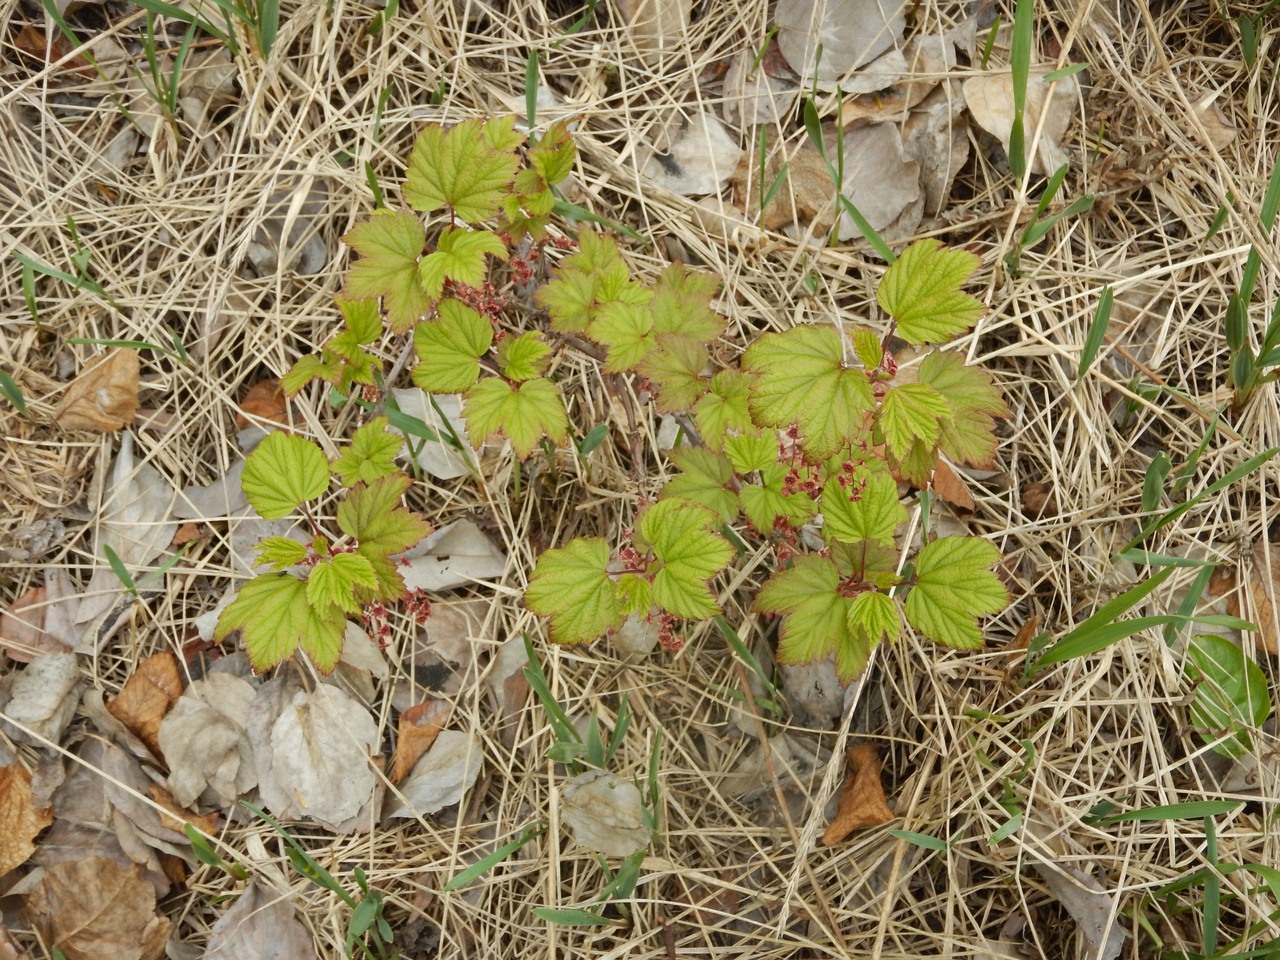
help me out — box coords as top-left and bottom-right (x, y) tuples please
(876, 239), (983, 343)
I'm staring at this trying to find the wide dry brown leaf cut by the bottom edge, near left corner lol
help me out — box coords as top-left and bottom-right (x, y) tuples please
(26, 856), (170, 960)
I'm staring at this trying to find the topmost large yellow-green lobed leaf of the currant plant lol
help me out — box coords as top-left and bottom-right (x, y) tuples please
(404, 116), (520, 224)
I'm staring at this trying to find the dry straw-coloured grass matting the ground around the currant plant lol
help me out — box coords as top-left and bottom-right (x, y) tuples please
(0, 0), (1280, 960)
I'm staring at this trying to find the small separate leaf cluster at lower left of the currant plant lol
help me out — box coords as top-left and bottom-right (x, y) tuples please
(214, 417), (431, 673)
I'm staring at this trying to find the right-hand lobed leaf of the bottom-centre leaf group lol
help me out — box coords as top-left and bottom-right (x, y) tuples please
(635, 499), (733, 620)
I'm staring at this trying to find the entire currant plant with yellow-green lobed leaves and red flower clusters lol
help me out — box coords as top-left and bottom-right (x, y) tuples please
(247, 118), (1009, 681)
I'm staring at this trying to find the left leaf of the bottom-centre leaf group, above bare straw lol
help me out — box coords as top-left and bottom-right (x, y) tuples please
(525, 538), (626, 644)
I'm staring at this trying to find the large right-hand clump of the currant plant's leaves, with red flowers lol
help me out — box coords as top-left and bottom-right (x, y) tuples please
(526, 239), (1009, 682)
